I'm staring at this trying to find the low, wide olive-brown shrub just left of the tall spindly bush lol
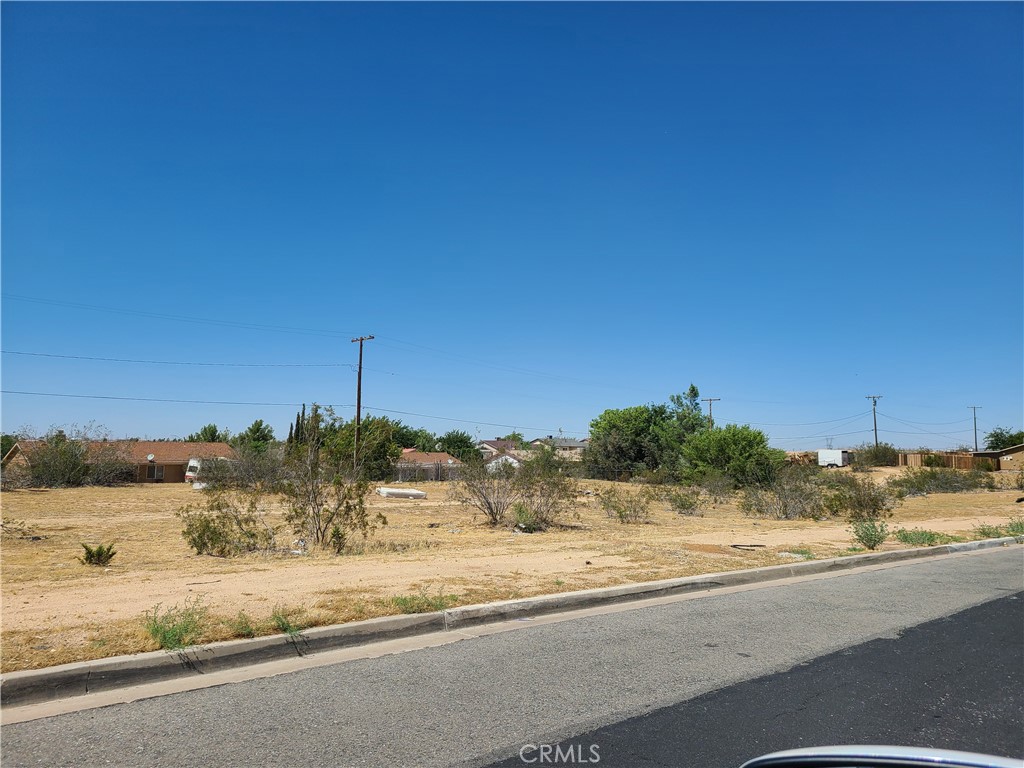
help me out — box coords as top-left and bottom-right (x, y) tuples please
(177, 492), (275, 557)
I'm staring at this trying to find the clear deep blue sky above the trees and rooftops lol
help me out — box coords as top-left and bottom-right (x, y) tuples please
(0, 2), (1024, 449)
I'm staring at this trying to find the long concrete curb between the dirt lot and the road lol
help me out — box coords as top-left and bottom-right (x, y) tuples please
(0, 537), (1024, 707)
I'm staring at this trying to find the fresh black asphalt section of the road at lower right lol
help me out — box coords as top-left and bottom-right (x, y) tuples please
(481, 592), (1024, 768)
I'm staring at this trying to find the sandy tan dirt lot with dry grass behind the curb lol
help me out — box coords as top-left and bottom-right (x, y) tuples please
(0, 472), (1021, 672)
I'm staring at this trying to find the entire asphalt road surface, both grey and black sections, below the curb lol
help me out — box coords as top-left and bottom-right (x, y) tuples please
(0, 547), (1024, 768)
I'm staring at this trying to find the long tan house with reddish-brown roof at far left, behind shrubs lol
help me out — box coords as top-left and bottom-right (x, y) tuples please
(0, 440), (238, 482)
